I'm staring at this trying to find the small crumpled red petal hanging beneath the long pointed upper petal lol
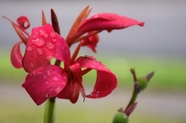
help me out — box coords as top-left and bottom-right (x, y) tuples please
(81, 32), (99, 53)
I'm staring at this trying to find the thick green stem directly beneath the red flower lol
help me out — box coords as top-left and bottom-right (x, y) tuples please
(44, 98), (55, 123)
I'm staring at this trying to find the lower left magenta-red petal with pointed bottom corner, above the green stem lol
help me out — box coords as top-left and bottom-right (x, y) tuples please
(22, 65), (68, 105)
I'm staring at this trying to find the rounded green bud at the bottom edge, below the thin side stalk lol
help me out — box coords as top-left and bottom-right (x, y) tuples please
(112, 112), (129, 123)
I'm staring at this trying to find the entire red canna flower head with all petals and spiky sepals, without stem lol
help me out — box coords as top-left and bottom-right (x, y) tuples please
(5, 6), (144, 105)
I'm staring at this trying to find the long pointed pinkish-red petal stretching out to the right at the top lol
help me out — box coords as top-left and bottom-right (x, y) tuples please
(76, 13), (144, 37)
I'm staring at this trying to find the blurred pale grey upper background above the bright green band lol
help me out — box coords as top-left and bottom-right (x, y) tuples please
(0, 0), (186, 59)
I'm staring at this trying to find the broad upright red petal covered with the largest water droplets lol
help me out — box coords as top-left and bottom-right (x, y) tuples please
(23, 24), (70, 72)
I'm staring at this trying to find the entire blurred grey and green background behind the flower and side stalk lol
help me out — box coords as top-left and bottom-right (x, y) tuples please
(0, 0), (186, 123)
